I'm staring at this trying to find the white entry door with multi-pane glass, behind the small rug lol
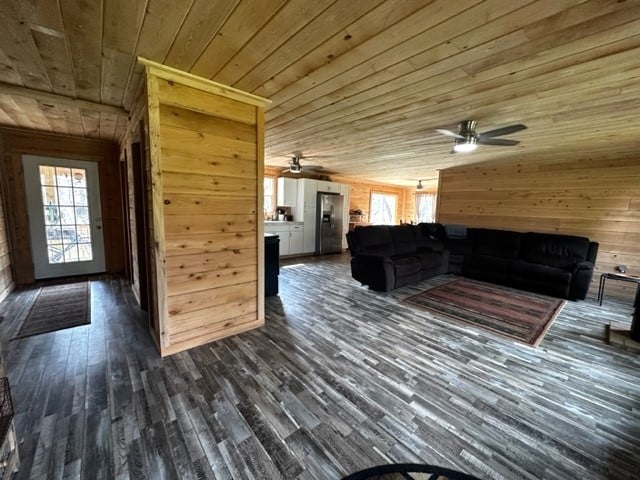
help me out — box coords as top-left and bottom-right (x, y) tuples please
(22, 155), (105, 279)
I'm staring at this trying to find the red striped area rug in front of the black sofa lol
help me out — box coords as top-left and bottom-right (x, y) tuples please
(404, 278), (566, 346)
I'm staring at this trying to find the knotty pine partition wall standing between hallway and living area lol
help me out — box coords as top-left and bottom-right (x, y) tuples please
(141, 59), (265, 355)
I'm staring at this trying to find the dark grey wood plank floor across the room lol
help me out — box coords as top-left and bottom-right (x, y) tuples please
(0, 255), (640, 480)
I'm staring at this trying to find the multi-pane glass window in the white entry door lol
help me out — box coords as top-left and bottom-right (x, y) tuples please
(39, 165), (93, 263)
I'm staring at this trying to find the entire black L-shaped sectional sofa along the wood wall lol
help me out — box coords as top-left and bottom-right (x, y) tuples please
(347, 223), (598, 299)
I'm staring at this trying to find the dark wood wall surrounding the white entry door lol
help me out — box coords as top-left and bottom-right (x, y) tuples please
(0, 128), (124, 285)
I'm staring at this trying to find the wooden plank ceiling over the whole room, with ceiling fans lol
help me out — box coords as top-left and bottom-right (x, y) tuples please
(0, 0), (640, 185)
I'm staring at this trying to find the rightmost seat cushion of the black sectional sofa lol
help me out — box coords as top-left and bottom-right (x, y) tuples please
(510, 260), (571, 298)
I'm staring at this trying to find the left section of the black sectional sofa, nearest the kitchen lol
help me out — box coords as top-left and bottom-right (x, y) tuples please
(347, 224), (449, 292)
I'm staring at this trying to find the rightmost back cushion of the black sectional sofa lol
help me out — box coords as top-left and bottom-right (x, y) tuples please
(520, 232), (589, 268)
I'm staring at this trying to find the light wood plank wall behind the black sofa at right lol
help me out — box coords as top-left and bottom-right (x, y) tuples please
(437, 153), (640, 298)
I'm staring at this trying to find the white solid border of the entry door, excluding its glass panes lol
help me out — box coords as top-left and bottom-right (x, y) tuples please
(21, 154), (106, 279)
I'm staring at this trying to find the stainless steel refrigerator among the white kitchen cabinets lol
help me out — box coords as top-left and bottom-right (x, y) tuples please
(316, 192), (344, 255)
